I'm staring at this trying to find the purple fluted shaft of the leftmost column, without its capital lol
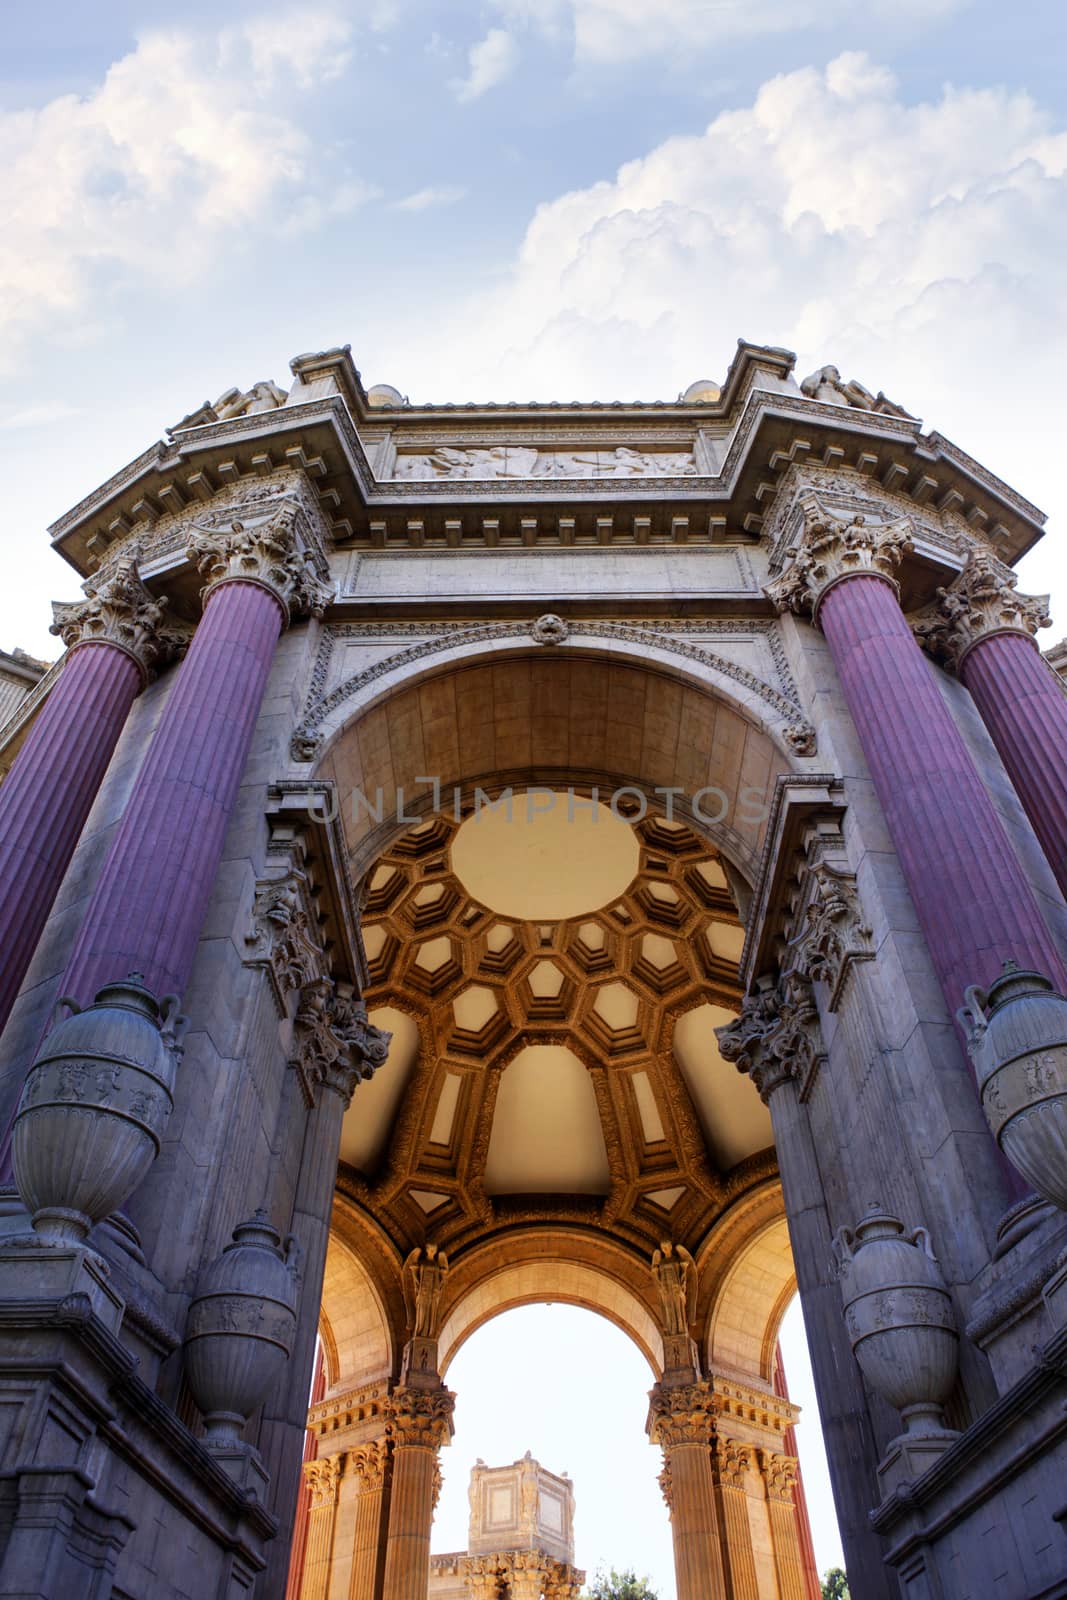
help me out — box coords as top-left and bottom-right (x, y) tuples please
(0, 640), (142, 1029)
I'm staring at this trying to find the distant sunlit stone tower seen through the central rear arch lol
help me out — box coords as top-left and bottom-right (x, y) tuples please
(430, 1451), (585, 1600)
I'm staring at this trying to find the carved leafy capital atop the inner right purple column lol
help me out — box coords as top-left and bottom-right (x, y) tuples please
(763, 496), (912, 621)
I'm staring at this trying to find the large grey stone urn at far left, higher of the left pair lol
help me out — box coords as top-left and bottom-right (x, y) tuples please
(11, 973), (186, 1243)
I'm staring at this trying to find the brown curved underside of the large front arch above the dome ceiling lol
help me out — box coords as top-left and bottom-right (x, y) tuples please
(317, 650), (792, 882)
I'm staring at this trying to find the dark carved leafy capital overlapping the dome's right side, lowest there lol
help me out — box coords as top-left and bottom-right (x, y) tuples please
(715, 971), (825, 1104)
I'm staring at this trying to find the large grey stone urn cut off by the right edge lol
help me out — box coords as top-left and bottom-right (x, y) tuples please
(958, 962), (1067, 1211)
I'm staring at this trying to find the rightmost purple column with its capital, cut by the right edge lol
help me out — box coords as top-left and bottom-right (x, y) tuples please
(920, 550), (1067, 894)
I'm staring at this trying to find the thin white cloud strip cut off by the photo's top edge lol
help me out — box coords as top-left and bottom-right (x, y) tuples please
(494, 0), (971, 62)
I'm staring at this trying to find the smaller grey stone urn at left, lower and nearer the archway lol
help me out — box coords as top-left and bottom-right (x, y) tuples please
(186, 1210), (299, 1445)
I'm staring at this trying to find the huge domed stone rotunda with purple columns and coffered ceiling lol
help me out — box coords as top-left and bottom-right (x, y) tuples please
(0, 344), (1067, 1600)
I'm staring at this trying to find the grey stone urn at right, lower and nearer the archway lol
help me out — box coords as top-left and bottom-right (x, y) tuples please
(833, 1205), (960, 1437)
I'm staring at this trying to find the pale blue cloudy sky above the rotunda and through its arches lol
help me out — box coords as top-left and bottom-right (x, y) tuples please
(0, 0), (1067, 1600)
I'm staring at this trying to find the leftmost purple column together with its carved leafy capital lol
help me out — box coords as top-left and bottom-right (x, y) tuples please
(0, 555), (182, 1029)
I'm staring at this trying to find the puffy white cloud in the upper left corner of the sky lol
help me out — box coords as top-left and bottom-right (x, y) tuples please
(0, 10), (366, 360)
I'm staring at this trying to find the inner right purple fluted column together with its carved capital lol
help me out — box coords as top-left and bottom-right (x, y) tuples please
(766, 502), (1067, 1016)
